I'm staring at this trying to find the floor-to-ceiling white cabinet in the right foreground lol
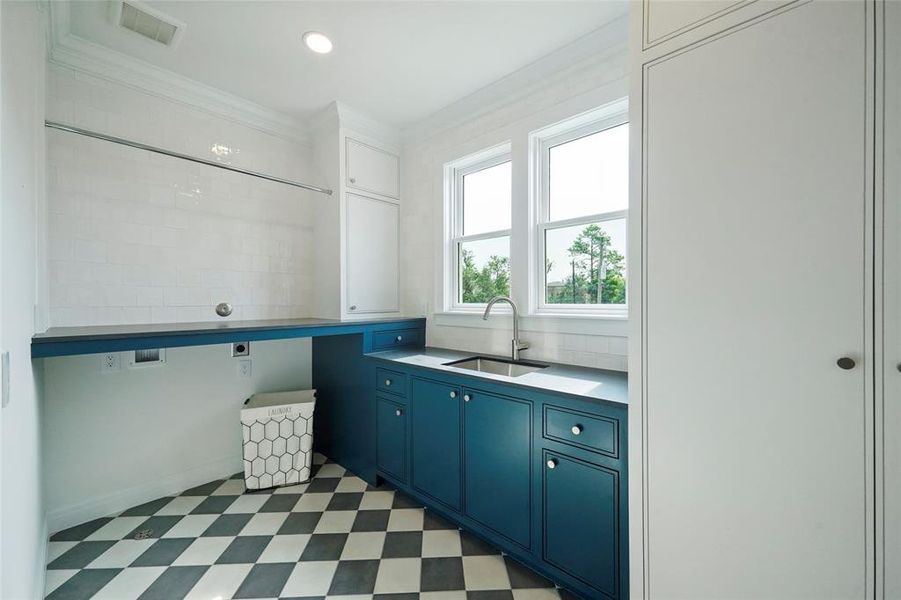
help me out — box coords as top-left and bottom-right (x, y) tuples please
(629, 0), (888, 599)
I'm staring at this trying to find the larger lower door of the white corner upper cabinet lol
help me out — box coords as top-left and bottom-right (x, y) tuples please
(347, 194), (399, 315)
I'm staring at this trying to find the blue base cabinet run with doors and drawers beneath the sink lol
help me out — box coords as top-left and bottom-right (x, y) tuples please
(371, 357), (629, 600)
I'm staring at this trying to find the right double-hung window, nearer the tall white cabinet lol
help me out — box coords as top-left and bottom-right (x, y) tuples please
(532, 103), (629, 316)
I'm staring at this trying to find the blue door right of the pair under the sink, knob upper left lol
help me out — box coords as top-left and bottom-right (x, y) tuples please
(463, 389), (532, 548)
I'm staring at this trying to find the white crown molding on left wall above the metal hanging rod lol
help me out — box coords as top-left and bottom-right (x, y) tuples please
(48, 2), (311, 145)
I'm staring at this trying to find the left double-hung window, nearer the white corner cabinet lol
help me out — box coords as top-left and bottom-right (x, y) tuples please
(445, 146), (513, 309)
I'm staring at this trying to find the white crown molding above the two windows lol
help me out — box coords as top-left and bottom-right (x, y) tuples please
(401, 15), (629, 145)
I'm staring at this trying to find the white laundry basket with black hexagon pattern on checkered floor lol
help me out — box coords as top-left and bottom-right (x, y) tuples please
(241, 390), (316, 490)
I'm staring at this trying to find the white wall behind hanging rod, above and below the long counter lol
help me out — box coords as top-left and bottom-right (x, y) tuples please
(43, 65), (329, 531)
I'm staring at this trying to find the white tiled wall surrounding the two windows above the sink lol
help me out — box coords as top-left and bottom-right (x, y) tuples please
(401, 47), (628, 371)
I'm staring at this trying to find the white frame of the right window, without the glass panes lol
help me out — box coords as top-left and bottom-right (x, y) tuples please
(529, 99), (629, 319)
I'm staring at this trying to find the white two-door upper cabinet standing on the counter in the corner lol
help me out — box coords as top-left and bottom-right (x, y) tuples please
(314, 103), (400, 319)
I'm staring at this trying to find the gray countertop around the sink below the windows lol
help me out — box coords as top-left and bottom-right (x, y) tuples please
(367, 348), (629, 404)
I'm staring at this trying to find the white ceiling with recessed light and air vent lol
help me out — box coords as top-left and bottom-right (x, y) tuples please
(70, 0), (628, 128)
